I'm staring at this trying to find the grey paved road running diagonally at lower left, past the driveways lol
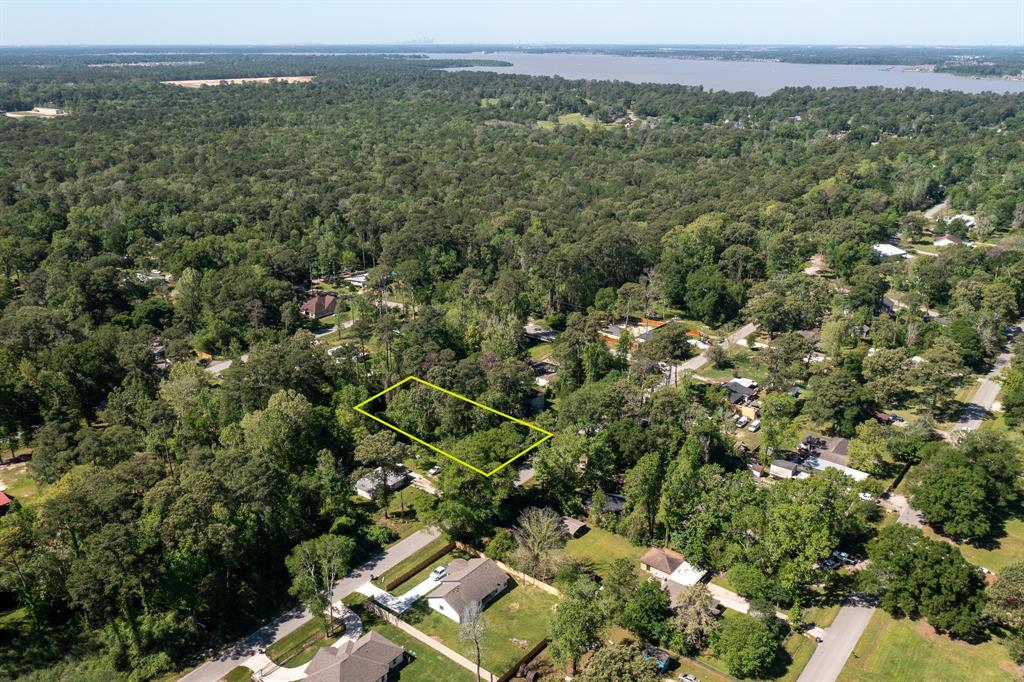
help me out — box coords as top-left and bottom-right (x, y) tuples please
(180, 529), (437, 682)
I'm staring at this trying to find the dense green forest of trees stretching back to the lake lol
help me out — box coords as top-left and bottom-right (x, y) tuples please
(0, 50), (1024, 680)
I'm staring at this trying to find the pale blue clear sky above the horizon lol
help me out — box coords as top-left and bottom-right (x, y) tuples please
(0, 0), (1024, 45)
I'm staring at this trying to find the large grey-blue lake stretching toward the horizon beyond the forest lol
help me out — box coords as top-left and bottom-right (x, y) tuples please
(427, 52), (1024, 95)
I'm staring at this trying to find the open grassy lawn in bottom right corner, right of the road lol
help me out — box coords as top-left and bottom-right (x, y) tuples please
(839, 608), (1017, 682)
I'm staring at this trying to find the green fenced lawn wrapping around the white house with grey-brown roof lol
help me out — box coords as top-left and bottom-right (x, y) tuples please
(404, 585), (558, 679)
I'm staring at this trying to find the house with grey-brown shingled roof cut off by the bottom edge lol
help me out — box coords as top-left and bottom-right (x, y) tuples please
(305, 631), (406, 682)
